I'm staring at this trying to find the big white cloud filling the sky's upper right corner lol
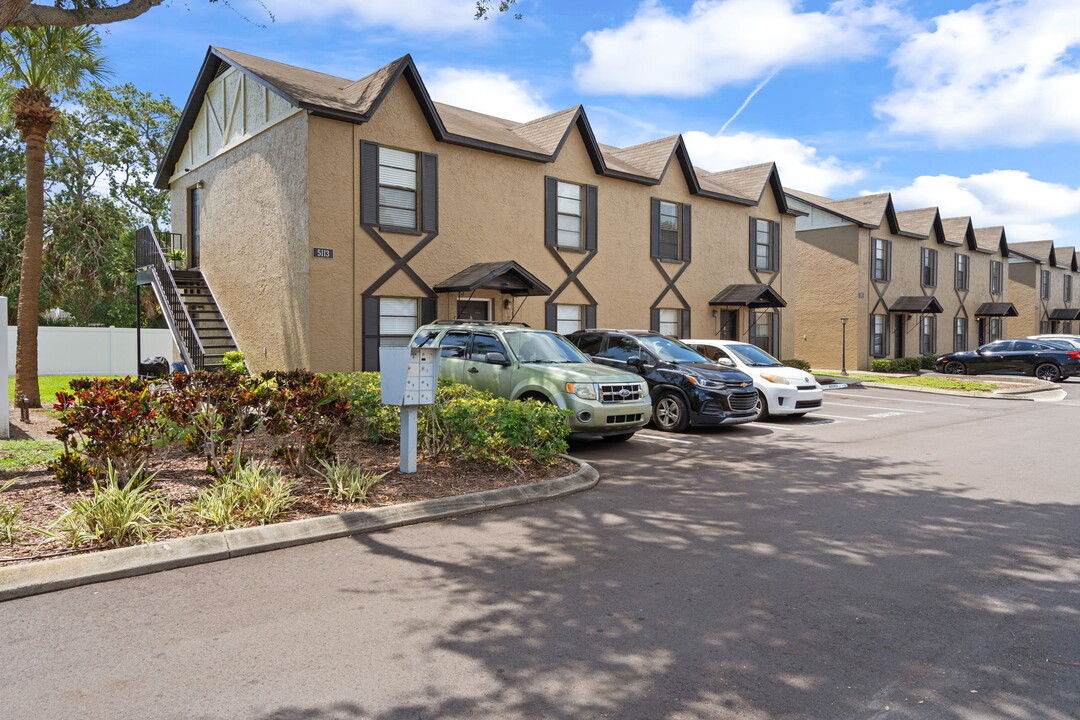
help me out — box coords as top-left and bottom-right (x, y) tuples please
(875, 0), (1080, 147)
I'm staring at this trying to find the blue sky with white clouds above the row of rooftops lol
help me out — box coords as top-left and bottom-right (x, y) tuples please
(97, 0), (1080, 245)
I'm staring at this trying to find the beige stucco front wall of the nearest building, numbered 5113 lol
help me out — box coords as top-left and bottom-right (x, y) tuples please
(308, 82), (795, 370)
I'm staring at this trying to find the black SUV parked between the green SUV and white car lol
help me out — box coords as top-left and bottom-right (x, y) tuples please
(567, 330), (758, 432)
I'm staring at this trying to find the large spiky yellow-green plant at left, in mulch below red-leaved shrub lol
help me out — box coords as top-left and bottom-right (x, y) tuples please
(43, 465), (173, 547)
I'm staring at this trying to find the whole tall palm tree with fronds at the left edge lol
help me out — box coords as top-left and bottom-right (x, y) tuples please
(0, 27), (108, 407)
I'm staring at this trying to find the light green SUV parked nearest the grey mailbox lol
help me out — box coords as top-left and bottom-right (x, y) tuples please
(410, 321), (652, 440)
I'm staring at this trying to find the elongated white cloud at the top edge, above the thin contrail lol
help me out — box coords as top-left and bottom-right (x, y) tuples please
(575, 0), (912, 97)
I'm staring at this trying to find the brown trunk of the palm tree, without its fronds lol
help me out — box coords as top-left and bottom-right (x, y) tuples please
(15, 131), (45, 407)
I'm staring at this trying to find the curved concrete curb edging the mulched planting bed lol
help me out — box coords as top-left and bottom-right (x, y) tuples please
(0, 456), (599, 601)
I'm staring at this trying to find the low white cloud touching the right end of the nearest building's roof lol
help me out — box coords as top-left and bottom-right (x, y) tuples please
(683, 131), (865, 195)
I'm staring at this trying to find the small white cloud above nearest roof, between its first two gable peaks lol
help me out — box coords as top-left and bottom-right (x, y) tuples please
(423, 68), (553, 122)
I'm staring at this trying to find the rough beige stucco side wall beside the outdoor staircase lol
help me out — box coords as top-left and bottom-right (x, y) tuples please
(171, 113), (310, 371)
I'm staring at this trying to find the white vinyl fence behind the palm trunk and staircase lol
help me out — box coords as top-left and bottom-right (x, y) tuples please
(6, 323), (179, 377)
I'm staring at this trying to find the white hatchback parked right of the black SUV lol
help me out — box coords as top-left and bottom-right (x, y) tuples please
(683, 340), (824, 420)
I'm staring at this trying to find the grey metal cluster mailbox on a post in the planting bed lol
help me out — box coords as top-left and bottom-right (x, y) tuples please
(379, 348), (438, 473)
